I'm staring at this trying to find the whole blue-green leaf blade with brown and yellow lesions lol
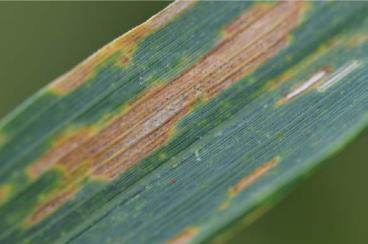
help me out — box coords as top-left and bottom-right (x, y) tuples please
(0, 1), (368, 243)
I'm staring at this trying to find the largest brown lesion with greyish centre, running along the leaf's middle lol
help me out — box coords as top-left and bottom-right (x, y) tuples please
(27, 2), (305, 225)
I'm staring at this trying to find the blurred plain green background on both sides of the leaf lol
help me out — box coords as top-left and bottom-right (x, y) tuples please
(0, 2), (368, 244)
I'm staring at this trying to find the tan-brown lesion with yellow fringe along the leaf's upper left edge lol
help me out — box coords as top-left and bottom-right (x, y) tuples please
(49, 1), (194, 95)
